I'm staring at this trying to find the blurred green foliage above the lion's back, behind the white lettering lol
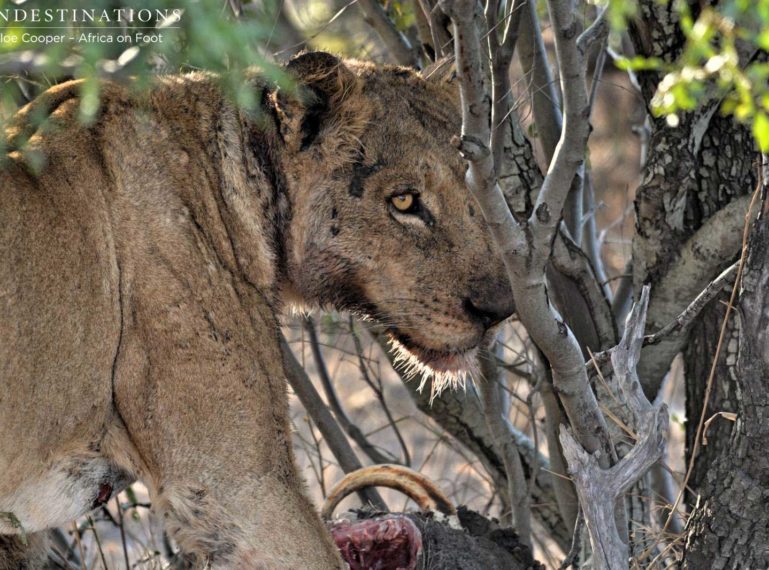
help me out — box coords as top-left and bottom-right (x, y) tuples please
(0, 0), (284, 121)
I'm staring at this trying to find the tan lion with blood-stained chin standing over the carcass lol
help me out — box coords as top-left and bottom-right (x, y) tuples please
(0, 53), (512, 570)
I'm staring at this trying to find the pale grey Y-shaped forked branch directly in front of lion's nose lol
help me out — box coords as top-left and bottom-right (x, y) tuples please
(441, 0), (611, 466)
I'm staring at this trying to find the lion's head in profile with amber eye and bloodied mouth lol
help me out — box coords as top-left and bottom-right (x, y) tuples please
(273, 53), (514, 389)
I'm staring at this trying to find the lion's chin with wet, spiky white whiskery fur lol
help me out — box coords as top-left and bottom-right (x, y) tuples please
(390, 332), (478, 403)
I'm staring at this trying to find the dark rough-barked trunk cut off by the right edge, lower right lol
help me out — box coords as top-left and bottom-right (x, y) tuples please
(683, 188), (769, 570)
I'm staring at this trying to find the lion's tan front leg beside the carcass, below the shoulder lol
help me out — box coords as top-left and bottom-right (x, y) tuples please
(115, 296), (342, 570)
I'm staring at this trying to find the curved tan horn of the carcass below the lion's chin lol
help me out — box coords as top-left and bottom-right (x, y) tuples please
(320, 464), (457, 520)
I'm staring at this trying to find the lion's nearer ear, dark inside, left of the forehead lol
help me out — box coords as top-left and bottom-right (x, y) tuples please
(273, 52), (360, 151)
